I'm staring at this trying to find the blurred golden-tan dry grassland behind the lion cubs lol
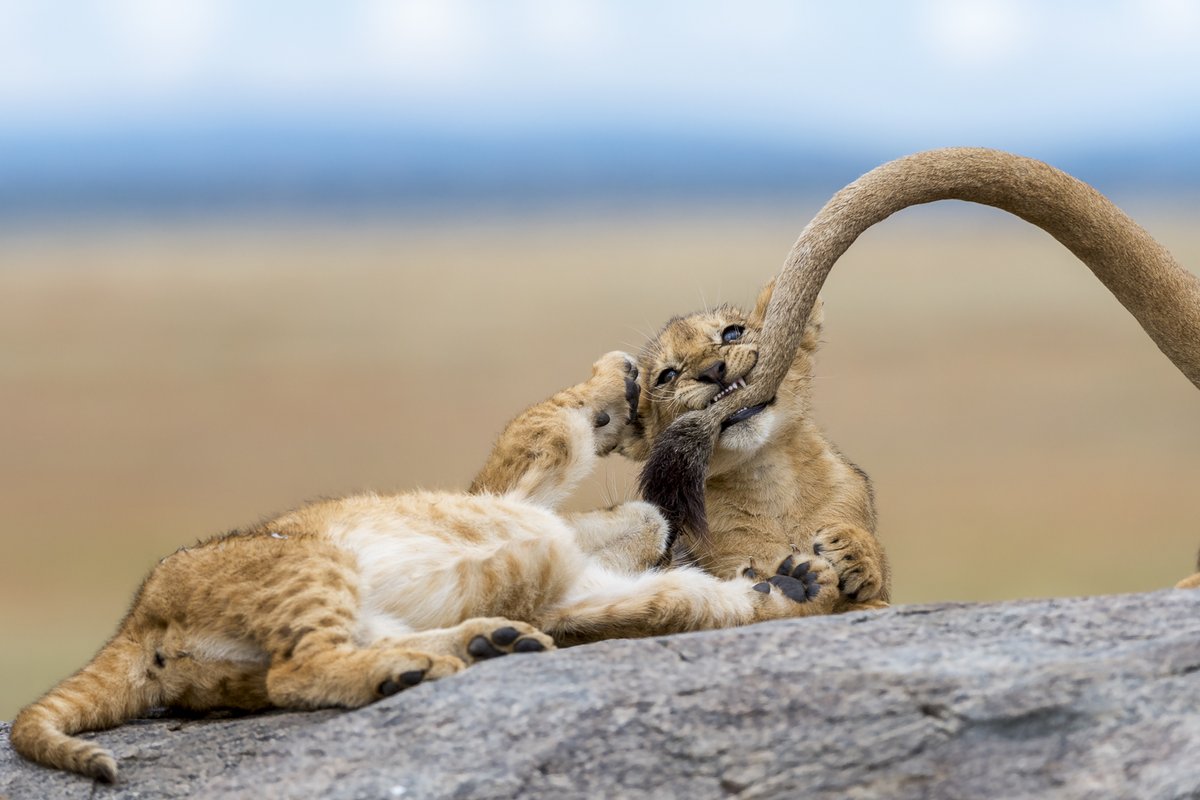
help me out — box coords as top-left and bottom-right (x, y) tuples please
(0, 206), (1200, 718)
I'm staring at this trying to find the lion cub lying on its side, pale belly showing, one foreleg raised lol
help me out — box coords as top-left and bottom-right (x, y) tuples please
(11, 353), (836, 781)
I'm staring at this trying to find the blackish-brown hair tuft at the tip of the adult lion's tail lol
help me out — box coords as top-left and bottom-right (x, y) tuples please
(640, 411), (718, 561)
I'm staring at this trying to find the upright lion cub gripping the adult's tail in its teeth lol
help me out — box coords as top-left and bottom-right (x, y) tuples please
(622, 282), (890, 612)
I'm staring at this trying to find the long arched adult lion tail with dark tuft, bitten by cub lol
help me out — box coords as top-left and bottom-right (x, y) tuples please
(642, 148), (1200, 568)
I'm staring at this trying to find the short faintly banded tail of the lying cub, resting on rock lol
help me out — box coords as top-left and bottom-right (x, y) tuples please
(8, 634), (157, 783)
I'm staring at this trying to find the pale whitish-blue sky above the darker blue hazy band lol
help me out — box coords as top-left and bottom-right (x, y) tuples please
(0, 0), (1200, 151)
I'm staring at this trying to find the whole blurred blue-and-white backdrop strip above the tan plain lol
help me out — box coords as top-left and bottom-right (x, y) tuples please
(0, 0), (1200, 222)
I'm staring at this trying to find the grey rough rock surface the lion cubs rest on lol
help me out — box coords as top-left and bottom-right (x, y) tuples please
(0, 591), (1200, 800)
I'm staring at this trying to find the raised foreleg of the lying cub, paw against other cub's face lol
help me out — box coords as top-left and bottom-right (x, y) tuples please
(469, 351), (638, 509)
